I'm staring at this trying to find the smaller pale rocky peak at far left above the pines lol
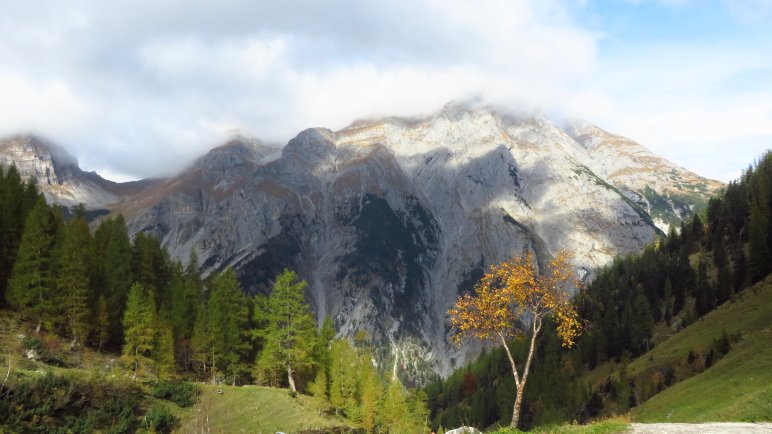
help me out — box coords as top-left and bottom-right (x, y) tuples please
(0, 134), (153, 212)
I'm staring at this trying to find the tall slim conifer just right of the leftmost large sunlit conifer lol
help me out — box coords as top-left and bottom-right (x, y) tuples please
(57, 206), (91, 344)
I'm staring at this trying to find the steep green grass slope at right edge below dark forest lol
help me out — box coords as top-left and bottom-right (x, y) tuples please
(629, 276), (772, 422)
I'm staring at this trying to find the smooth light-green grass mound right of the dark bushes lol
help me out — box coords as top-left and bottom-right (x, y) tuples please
(177, 385), (346, 433)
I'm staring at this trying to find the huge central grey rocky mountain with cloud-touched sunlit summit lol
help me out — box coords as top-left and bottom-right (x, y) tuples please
(0, 105), (721, 378)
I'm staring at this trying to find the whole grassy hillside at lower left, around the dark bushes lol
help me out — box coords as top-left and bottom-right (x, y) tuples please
(0, 309), (347, 434)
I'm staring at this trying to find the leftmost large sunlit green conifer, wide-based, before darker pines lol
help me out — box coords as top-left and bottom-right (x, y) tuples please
(6, 197), (57, 332)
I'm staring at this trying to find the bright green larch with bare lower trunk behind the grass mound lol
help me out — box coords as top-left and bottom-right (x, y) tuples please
(258, 269), (316, 391)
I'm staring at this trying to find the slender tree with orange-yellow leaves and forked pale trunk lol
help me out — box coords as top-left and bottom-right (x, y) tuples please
(448, 251), (581, 428)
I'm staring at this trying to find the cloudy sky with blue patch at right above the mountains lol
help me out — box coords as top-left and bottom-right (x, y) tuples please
(0, 0), (772, 181)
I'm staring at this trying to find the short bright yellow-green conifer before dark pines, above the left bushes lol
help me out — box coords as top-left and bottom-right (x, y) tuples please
(123, 283), (156, 380)
